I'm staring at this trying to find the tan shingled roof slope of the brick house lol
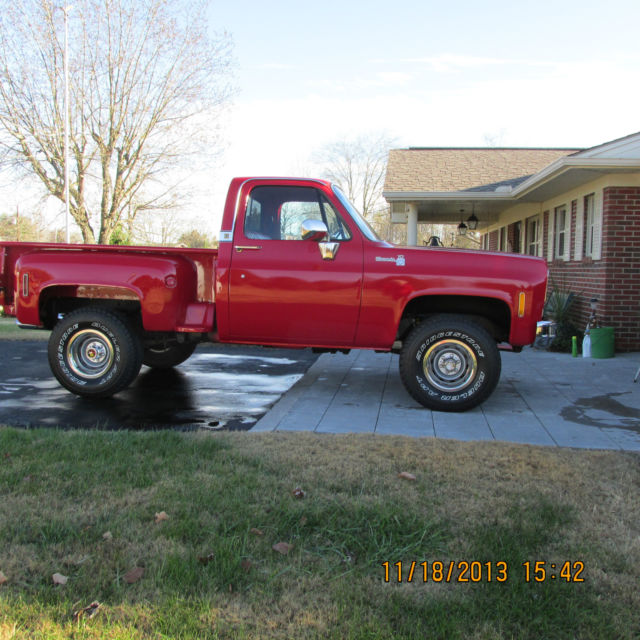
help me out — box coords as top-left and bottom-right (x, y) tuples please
(384, 148), (582, 192)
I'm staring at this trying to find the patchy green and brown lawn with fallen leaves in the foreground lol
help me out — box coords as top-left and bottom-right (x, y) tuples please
(0, 428), (640, 640)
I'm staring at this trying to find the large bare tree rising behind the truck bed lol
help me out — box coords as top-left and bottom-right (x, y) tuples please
(0, 0), (231, 243)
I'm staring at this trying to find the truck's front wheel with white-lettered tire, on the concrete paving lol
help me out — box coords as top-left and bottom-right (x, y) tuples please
(400, 315), (502, 412)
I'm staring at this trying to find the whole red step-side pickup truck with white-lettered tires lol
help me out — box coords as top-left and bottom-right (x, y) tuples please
(0, 178), (547, 411)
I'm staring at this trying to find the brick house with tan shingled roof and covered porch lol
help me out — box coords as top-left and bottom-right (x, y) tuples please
(384, 133), (640, 351)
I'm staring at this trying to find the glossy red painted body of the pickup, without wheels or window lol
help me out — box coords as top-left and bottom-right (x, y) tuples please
(0, 178), (547, 350)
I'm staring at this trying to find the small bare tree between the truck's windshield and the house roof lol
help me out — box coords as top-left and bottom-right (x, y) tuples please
(314, 133), (395, 220)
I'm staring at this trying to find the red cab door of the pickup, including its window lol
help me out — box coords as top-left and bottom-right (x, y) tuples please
(229, 184), (363, 346)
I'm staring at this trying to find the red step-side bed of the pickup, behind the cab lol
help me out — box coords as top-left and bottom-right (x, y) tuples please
(3, 243), (217, 332)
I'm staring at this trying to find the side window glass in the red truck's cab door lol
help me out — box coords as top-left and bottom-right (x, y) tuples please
(244, 186), (351, 241)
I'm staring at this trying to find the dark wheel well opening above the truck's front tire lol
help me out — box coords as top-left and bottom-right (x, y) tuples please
(396, 296), (511, 342)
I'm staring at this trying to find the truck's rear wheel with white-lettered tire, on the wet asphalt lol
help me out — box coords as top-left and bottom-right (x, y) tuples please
(48, 307), (142, 398)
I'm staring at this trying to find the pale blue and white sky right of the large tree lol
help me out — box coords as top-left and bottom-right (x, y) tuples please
(204, 0), (640, 225)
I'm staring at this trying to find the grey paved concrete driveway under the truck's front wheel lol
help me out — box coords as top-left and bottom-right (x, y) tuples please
(252, 348), (640, 451)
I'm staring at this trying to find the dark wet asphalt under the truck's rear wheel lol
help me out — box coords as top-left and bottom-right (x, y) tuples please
(0, 340), (317, 430)
